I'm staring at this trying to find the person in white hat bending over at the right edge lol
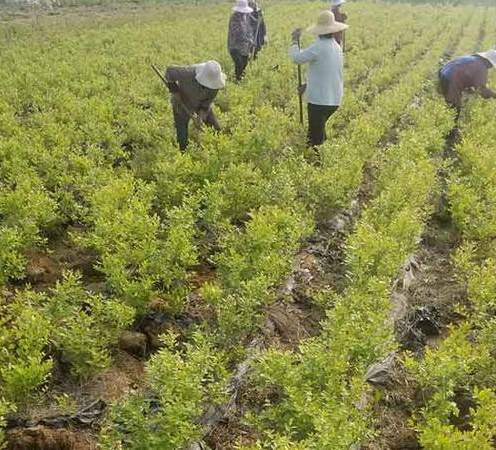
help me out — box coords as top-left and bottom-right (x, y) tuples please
(439, 50), (496, 113)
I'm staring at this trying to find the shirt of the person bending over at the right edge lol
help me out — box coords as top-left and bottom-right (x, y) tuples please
(439, 55), (496, 97)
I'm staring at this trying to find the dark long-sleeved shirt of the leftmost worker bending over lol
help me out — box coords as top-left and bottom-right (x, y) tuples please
(165, 66), (218, 123)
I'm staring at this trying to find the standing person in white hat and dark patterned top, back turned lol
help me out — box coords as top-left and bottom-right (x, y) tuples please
(227, 0), (255, 81)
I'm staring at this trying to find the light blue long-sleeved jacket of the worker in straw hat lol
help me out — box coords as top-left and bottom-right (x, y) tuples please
(289, 37), (343, 106)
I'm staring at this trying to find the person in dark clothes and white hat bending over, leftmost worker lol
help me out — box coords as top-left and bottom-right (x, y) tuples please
(165, 61), (226, 151)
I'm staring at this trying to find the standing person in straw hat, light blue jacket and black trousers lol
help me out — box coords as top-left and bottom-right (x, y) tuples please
(289, 11), (348, 146)
